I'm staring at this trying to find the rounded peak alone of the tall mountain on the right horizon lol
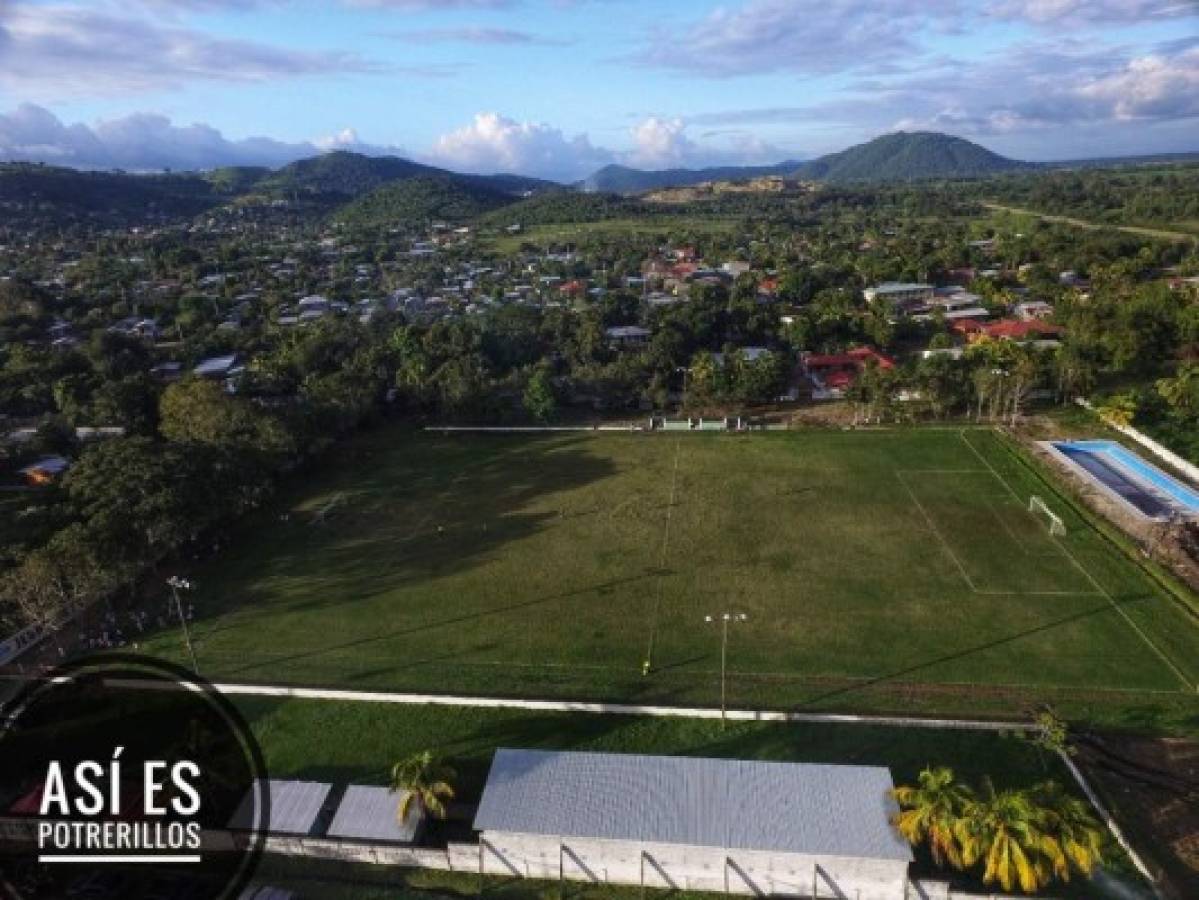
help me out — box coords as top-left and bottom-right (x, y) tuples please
(795, 132), (1035, 181)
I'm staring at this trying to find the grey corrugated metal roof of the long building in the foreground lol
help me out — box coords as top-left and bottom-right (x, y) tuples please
(475, 750), (912, 860)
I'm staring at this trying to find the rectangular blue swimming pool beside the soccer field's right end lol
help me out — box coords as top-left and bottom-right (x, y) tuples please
(1053, 441), (1199, 519)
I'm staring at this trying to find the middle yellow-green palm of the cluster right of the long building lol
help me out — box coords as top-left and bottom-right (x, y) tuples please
(954, 780), (1065, 894)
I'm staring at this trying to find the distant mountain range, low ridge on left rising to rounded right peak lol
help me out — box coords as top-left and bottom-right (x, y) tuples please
(579, 132), (1035, 194)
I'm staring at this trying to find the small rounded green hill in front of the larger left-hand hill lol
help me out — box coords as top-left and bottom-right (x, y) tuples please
(336, 175), (516, 225)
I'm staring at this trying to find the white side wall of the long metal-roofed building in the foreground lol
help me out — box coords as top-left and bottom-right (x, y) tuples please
(483, 832), (908, 900)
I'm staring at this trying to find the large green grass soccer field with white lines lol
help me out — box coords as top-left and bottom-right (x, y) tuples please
(151, 429), (1199, 713)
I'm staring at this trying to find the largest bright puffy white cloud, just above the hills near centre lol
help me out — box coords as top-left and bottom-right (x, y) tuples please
(429, 113), (613, 180)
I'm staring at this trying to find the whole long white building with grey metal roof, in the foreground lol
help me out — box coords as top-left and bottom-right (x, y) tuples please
(475, 749), (912, 900)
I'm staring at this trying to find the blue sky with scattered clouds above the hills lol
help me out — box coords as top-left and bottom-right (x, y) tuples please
(0, 0), (1199, 181)
